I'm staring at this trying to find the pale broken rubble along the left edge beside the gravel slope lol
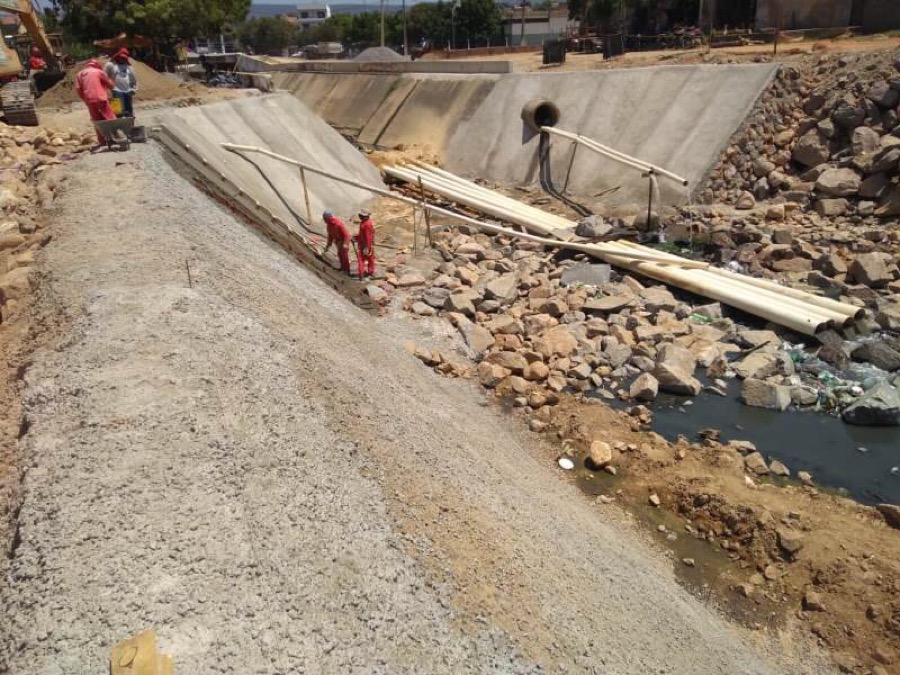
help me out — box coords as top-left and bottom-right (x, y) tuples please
(0, 126), (93, 323)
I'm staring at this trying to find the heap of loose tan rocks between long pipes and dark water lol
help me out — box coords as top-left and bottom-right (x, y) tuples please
(392, 231), (900, 428)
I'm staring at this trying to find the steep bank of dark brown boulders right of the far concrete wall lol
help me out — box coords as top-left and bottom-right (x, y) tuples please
(699, 52), (900, 218)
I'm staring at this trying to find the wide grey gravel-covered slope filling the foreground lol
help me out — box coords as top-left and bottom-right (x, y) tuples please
(0, 145), (822, 675)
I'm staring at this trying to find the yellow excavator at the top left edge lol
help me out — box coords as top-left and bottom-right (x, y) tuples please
(0, 0), (65, 126)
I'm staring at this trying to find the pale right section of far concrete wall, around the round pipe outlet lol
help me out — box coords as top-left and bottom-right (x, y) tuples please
(444, 64), (776, 203)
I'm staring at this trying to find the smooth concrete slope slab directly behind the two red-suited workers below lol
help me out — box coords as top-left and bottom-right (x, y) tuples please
(161, 93), (383, 233)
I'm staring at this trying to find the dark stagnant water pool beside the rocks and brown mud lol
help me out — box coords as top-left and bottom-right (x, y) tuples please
(632, 380), (900, 504)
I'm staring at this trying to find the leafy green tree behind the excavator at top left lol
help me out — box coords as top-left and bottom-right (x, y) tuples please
(53, 0), (251, 42)
